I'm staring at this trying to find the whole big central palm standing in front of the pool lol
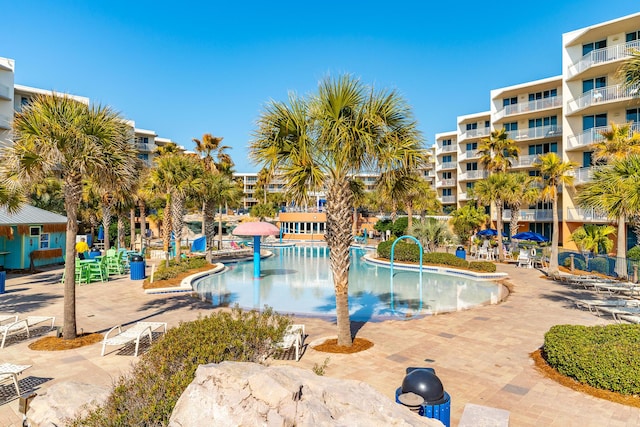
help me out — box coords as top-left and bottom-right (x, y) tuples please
(250, 75), (426, 346)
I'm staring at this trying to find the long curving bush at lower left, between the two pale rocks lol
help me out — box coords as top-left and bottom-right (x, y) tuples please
(71, 307), (291, 427)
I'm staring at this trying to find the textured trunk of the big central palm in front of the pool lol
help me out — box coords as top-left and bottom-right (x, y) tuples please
(325, 179), (353, 347)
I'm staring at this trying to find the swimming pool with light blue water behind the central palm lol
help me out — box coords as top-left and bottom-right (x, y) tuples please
(193, 246), (503, 321)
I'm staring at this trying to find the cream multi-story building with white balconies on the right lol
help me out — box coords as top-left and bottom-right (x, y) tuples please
(435, 13), (640, 251)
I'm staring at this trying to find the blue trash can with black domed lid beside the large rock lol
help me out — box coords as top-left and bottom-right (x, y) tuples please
(396, 368), (451, 427)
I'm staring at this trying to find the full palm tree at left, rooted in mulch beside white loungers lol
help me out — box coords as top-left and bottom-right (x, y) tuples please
(4, 94), (137, 339)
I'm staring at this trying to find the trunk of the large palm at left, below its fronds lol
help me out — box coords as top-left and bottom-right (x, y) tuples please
(62, 175), (82, 340)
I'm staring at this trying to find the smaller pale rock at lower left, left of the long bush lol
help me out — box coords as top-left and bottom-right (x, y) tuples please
(27, 381), (111, 427)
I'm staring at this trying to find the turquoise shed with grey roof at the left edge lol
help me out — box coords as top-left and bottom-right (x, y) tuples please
(0, 205), (67, 270)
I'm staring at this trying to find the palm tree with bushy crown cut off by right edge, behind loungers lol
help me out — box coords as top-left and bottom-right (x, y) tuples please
(576, 154), (640, 277)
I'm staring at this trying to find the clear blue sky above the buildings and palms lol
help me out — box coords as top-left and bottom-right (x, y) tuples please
(5, 0), (640, 172)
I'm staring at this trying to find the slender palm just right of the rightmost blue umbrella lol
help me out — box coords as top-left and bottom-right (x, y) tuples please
(533, 153), (577, 277)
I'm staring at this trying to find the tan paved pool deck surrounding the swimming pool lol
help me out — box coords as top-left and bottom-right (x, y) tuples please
(0, 265), (640, 427)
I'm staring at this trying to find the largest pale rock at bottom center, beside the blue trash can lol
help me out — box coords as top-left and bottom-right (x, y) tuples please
(169, 362), (442, 427)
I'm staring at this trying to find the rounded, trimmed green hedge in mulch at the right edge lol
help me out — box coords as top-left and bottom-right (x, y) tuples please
(543, 325), (640, 394)
